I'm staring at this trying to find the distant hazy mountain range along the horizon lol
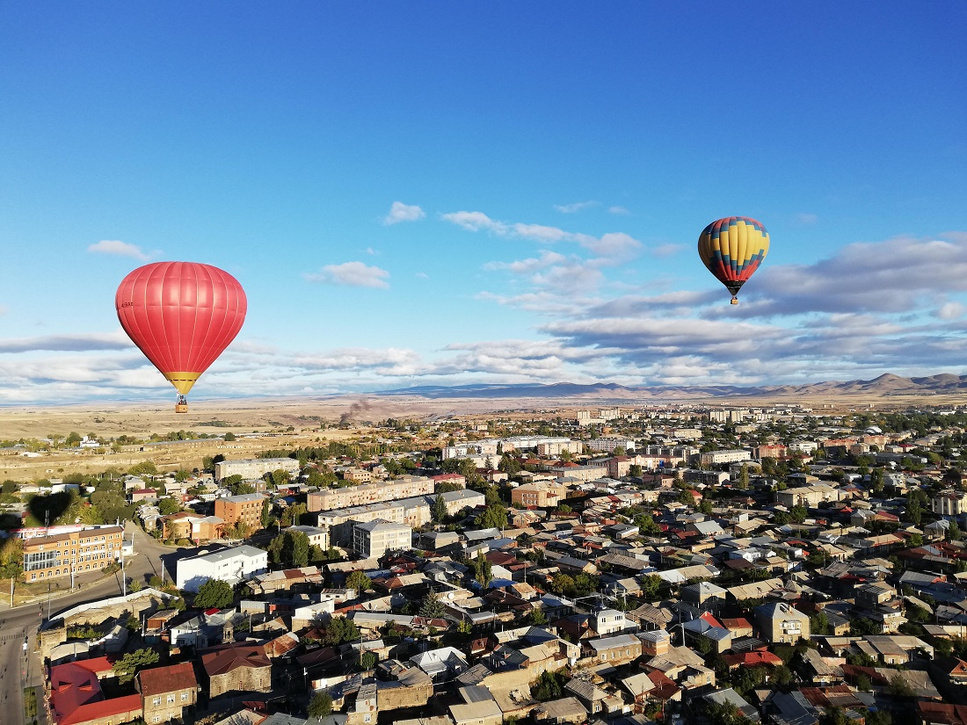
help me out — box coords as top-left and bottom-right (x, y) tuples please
(376, 373), (967, 403)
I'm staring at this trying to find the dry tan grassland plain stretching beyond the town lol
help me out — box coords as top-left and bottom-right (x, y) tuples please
(0, 393), (967, 480)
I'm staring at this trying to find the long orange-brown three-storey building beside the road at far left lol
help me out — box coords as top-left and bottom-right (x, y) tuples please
(23, 526), (124, 582)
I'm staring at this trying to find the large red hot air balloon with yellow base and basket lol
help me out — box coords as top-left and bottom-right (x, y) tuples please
(114, 262), (247, 413)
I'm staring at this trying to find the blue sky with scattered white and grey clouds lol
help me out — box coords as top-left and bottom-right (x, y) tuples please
(0, 1), (967, 405)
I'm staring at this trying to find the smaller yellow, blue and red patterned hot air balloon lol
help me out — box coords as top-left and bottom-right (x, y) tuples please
(698, 216), (769, 305)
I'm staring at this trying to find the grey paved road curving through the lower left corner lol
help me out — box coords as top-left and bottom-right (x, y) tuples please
(0, 522), (175, 723)
